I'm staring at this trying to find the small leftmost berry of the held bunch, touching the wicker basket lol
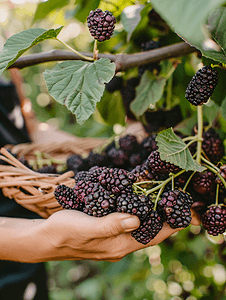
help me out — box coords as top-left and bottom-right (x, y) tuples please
(54, 184), (82, 210)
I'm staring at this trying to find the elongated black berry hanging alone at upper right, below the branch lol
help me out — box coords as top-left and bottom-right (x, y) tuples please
(185, 66), (219, 106)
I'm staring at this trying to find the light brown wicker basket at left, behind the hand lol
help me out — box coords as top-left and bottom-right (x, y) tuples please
(0, 138), (104, 218)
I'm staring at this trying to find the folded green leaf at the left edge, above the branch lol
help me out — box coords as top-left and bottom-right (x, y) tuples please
(0, 26), (63, 75)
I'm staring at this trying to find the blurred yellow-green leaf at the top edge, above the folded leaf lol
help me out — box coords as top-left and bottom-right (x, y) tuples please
(33, 0), (69, 22)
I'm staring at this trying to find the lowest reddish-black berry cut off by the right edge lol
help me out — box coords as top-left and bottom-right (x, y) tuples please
(202, 205), (226, 236)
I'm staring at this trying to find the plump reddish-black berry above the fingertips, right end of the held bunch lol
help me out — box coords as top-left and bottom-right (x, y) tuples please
(157, 189), (193, 229)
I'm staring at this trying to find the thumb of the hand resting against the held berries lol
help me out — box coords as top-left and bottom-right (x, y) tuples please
(95, 213), (140, 238)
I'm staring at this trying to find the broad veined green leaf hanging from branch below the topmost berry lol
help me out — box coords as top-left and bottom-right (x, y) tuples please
(43, 58), (115, 124)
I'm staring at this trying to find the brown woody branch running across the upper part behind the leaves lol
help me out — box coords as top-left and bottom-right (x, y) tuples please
(9, 42), (198, 72)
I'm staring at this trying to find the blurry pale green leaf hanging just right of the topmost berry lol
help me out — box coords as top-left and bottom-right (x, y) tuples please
(121, 4), (145, 39)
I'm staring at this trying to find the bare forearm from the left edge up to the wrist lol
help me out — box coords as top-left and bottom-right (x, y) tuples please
(0, 217), (51, 262)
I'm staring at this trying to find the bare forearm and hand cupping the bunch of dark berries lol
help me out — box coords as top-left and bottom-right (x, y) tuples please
(0, 210), (201, 262)
